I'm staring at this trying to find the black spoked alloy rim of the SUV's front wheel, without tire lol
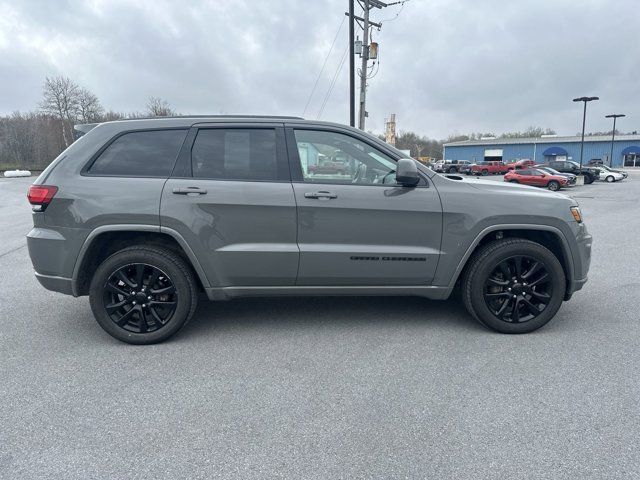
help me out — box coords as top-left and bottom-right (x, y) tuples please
(483, 255), (553, 323)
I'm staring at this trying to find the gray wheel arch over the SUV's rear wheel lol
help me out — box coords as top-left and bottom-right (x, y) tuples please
(71, 225), (210, 297)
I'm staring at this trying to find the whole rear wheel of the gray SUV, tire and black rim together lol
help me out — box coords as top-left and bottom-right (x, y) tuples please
(89, 245), (198, 345)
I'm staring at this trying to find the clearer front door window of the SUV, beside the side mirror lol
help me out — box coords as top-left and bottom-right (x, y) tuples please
(295, 130), (400, 185)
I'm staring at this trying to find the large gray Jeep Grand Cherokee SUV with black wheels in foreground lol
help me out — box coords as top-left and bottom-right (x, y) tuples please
(27, 117), (591, 344)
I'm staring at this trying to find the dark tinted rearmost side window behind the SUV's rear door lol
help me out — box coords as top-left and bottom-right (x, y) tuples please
(89, 130), (187, 177)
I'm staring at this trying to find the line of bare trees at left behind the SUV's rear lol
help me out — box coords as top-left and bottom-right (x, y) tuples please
(0, 76), (176, 170)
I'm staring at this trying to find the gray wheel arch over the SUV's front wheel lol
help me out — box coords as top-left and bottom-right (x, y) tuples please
(449, 224), (574, 296)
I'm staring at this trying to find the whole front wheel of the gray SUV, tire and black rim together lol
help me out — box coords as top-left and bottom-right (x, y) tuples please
(462, 238), (566, 334)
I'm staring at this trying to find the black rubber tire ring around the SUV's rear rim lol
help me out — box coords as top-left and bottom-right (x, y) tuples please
(89, 249), (192, 344)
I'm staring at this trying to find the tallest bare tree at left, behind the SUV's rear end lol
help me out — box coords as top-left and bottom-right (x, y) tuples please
(40, 76), (80, 147)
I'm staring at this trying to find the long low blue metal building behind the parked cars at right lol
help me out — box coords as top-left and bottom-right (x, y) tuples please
(443, 135), (640, 167)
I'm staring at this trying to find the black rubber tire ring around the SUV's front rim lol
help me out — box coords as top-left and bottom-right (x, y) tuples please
(471, 242), (566, 333)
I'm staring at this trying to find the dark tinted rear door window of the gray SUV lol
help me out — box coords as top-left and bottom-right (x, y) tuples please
(191, 128), (280, 181)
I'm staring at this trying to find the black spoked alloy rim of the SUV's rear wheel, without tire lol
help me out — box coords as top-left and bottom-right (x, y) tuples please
(104, 263), (178, 333)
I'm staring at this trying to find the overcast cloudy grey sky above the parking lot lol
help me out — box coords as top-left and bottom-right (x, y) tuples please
(0, 0), (640, 138)
